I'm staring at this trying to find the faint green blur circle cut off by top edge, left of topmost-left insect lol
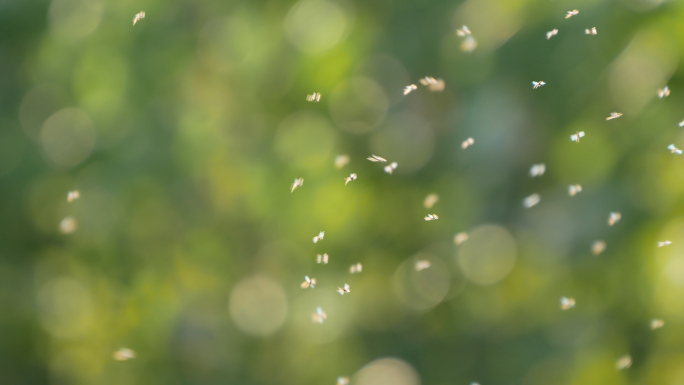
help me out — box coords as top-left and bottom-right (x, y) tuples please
(48, 0), (104, 40)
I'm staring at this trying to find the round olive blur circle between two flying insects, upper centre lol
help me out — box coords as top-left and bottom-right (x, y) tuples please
(328, 77), (389, 134)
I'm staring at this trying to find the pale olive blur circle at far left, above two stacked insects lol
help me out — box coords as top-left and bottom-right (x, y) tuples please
(40, 108), (95, 167)
